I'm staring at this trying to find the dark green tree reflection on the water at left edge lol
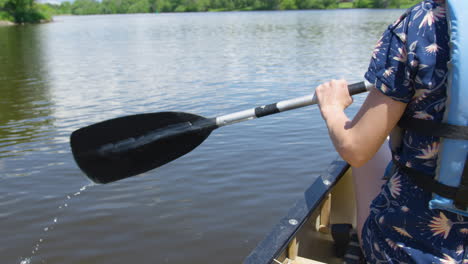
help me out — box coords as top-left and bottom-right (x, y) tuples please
(0, 26), (53, 158)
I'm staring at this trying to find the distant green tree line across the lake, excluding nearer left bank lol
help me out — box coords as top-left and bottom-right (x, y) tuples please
(49, 0), (417, 15)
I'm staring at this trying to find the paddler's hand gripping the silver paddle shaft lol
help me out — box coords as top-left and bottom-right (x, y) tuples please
(315, 80), (353, 117)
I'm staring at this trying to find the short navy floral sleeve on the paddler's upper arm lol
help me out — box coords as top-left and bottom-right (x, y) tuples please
(365, 13), (415, 103)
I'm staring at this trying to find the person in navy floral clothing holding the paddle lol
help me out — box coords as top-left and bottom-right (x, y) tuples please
(316, 0), (468, 264)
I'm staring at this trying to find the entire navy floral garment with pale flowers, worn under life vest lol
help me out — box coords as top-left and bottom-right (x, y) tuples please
(362, 0), (468, 264)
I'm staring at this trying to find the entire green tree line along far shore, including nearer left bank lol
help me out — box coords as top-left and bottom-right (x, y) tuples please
(0, 0), (419, 23)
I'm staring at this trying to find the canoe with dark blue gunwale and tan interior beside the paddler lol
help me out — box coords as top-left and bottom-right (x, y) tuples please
(243, 160), (356, 264)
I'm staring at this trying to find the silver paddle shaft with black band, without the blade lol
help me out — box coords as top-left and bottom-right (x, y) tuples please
(211, 81), (373, 127)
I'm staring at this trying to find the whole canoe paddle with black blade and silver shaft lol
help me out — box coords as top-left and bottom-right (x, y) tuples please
(70, 82), (371, 183)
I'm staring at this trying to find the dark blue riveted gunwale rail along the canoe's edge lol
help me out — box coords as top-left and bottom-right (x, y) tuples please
(243, 158), (349, 264)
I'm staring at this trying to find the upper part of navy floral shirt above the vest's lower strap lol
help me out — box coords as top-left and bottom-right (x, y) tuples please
(365, 1), (450, 174)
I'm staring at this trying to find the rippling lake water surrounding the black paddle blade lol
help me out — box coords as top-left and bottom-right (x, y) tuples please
(0, 10), (402, 264)
